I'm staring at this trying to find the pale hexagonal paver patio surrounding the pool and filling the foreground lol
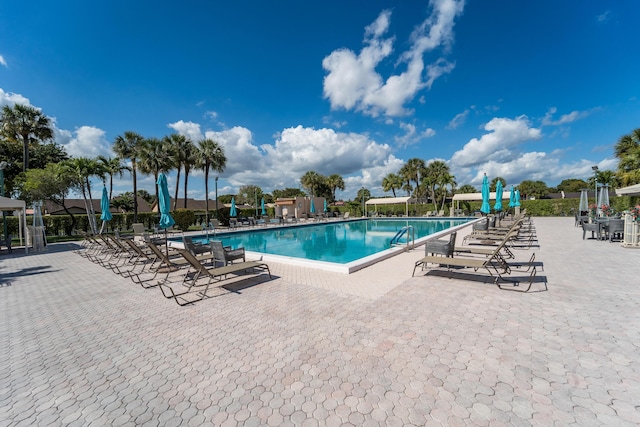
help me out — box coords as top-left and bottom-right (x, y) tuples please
(0, 218), (640, 426)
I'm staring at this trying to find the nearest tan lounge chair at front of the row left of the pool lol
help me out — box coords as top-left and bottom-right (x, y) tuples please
(159, 249), (271, 305)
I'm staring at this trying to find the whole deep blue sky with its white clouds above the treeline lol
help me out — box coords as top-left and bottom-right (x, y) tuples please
(0, 0), (640, 199)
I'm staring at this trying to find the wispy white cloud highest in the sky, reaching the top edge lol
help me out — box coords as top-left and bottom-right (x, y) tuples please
(322, 0), (464, 117)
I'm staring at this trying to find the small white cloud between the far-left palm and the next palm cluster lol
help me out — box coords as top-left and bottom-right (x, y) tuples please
(54, 126), (114, 158)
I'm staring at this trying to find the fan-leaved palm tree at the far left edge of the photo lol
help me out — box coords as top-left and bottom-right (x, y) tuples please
(0, 104), (53, 171)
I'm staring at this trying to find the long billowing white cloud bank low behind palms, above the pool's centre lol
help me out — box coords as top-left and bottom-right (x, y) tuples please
(170, 122), (404, 198)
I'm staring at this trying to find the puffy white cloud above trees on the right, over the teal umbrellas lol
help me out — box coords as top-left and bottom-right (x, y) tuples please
(451, 116), (542, 167)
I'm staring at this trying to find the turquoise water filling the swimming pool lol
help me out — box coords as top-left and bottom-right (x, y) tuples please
(176, 218), (470, 264)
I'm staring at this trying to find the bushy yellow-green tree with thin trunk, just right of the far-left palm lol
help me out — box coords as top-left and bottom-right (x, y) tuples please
(19, 163), (77, 236)
